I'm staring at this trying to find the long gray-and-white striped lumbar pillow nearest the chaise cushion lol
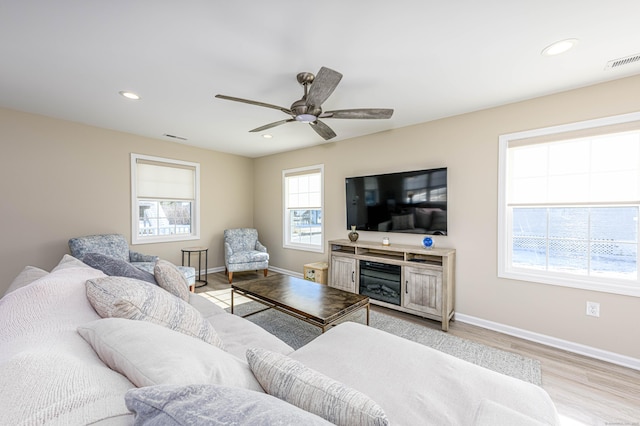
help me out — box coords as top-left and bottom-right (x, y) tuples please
(247, 349), (389, 426)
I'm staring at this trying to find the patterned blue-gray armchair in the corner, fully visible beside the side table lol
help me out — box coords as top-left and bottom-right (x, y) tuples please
(224, 228), (269, 284)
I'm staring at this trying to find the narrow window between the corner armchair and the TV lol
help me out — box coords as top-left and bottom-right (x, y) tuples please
(282, 165), (324, 253)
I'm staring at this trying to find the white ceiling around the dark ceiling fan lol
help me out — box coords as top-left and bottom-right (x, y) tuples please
(0, 0), (640, 157)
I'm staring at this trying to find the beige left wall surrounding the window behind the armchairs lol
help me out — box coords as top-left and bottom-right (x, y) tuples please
(0, 109), (253, 294)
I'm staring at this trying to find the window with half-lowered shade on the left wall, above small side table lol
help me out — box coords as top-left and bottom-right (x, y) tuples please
(131, 154), (200, 244)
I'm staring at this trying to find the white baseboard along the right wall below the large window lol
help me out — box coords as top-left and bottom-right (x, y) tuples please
(455, 312), (640, 370)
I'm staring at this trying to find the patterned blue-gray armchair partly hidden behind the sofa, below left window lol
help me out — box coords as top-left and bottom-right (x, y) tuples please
(69, 234), (196, 286)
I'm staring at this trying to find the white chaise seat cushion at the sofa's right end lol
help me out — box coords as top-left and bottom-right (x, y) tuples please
(289, 322), (558, 425)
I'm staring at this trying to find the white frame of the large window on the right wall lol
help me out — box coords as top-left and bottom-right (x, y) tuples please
(497, 112), (640, 297)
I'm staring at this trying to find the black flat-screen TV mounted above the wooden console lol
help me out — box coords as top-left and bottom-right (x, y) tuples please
(345, 167), (447, 235)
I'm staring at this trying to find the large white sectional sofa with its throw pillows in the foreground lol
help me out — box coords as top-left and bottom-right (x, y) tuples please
(0, 256), (558, 426)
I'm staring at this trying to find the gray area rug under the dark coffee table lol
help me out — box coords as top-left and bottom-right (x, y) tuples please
(227, 302), (542, 385)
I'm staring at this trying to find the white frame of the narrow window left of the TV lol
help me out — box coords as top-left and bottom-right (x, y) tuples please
(282, 164), (325, 253)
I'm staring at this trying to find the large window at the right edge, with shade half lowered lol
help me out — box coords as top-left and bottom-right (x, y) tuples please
(498, 113), (640, 297)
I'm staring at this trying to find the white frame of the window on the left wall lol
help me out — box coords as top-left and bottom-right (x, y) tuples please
(131, 153), (200, 245)
